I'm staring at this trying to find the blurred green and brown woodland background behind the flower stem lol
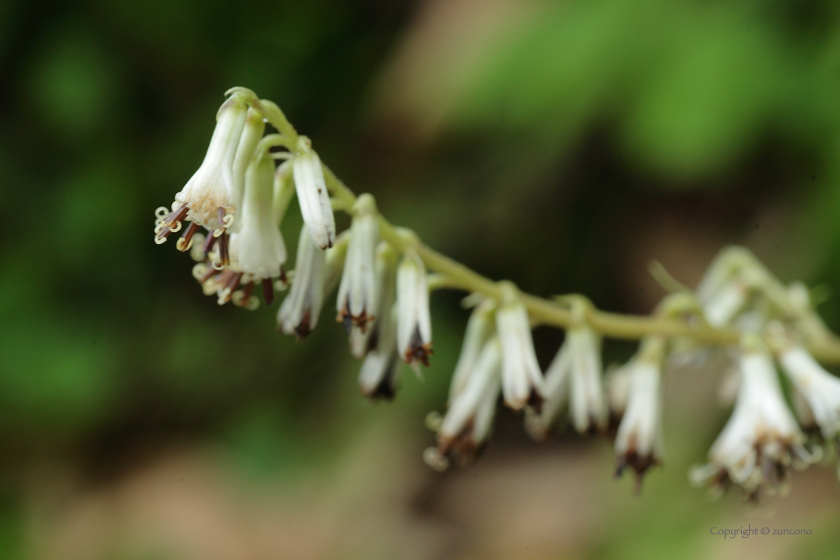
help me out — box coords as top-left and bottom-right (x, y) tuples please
(0, 0), (840, 560)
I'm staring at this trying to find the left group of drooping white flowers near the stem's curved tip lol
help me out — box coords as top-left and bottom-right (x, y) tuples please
(155, 88), (440, 399)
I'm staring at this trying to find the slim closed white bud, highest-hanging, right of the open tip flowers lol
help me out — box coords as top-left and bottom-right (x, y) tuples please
(292, 136), (335, 249)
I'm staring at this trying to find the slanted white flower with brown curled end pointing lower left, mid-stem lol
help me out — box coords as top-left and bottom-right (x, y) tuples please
(424, 337), (502, 470)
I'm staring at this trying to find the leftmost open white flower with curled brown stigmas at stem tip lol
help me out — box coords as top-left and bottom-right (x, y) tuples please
(155, 93), (248, 258)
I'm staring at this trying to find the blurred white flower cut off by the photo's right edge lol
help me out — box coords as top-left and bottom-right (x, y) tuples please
(779, 346), (840, 440)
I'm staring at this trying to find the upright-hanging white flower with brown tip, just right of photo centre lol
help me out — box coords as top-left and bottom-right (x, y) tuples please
(496, 285), (544, 410)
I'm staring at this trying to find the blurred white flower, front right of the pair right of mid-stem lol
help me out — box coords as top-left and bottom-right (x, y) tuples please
(566, 326), (609, 433)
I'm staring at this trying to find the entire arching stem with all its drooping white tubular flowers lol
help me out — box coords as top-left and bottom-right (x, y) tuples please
(155, 88), (840, 497)
